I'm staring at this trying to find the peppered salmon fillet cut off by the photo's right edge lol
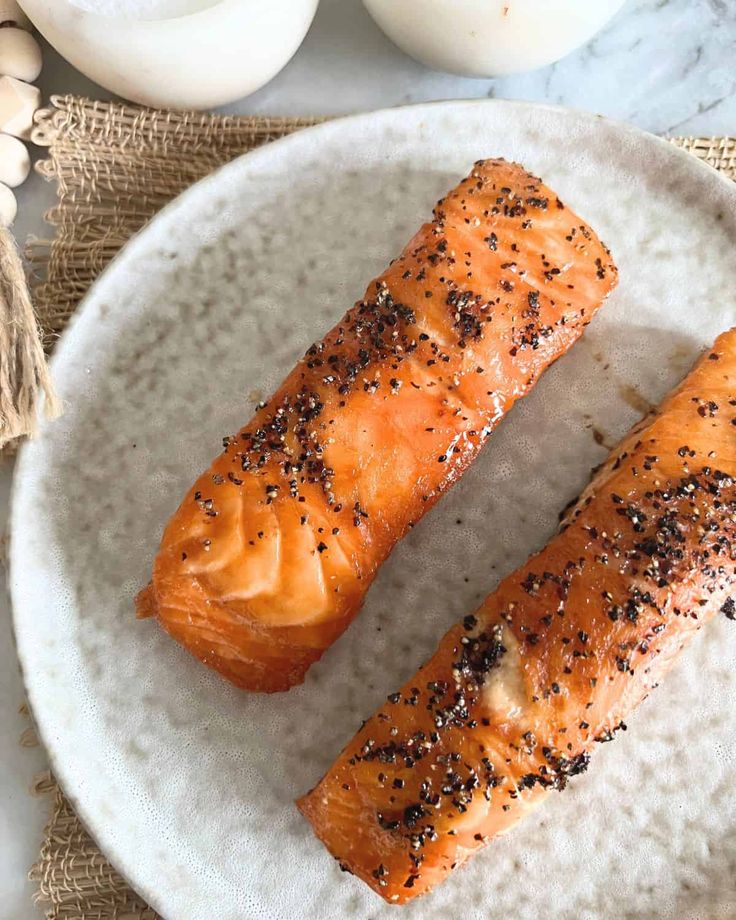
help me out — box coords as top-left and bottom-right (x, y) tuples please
(298, 330), (736, 904)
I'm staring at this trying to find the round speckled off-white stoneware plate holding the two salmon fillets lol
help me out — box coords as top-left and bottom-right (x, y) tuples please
(12, 102), (736, 920)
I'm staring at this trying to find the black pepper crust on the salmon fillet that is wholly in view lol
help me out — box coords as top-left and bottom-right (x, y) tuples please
(195, 159), (616, 560)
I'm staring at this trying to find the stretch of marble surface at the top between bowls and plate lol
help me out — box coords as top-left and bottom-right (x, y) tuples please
(243, 0), (736, 134)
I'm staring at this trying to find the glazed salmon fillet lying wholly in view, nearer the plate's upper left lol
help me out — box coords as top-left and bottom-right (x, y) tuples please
(138, 160), (616, 691)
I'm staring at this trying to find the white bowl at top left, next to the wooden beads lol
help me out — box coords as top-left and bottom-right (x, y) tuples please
(20, 0), (319, 109)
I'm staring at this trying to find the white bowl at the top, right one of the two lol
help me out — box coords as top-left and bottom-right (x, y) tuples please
(363, 0), (625, 77)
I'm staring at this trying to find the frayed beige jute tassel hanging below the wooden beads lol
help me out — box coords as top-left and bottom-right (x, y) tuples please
(0, 228), (61, 448)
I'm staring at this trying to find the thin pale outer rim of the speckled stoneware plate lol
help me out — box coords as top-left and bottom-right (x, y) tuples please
(7, 99), (736, 916)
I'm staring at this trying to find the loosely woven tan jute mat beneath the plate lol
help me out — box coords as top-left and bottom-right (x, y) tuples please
(21, 96), (736, 920)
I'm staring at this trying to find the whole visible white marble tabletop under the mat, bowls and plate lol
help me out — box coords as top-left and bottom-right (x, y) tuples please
(0, 0), (736, 920)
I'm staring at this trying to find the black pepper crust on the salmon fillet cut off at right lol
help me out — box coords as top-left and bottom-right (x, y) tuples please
(326, 348), (736, 887)
